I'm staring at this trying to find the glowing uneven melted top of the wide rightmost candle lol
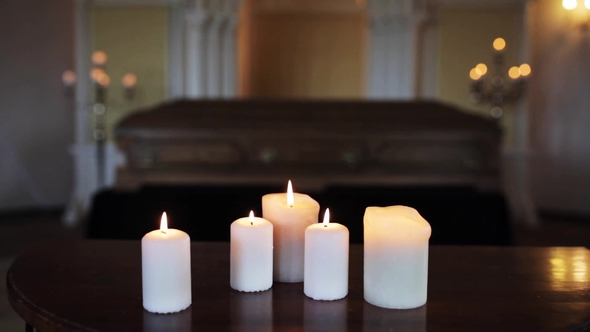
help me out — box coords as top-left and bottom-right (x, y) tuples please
(364, 205), (432, 240)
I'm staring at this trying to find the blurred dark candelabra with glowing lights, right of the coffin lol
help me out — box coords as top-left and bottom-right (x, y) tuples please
(469, 37), (536, 119)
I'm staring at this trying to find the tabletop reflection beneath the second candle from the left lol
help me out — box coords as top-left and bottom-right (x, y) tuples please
(230, 289), (273, 332)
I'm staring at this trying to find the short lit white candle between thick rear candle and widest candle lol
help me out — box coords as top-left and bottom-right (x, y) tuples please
(303, 209), (348, 301)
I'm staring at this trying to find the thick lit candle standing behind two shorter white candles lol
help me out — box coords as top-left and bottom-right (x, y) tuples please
(262, 181), (320, 282)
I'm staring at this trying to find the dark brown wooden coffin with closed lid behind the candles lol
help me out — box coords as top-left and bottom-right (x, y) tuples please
(115, 100), (501, 188)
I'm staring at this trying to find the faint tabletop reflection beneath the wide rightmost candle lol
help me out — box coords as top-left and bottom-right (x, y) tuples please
(363, 302), (427, 332)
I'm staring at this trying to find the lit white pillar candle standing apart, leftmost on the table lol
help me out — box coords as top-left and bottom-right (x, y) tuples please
(141, 213), (191, 314)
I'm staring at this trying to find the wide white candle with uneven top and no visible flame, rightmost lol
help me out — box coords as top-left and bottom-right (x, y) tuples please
(364, 206), (431, 309)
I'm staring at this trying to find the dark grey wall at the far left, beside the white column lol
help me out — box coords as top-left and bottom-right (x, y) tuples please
(0, 0), (74, 211)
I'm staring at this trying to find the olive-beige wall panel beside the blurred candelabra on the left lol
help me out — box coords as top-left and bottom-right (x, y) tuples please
(91, 6), (168, 139)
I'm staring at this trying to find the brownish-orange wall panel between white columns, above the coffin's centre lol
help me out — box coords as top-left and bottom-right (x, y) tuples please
(240, 11), (366, 98)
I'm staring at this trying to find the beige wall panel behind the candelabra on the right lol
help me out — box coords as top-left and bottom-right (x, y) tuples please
(437, 8), (522, 147)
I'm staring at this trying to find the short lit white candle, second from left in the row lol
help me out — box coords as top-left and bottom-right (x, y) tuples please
(230, 211), (273, 292)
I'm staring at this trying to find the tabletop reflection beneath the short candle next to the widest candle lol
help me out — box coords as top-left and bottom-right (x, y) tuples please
(303, 298), (348, 332)
